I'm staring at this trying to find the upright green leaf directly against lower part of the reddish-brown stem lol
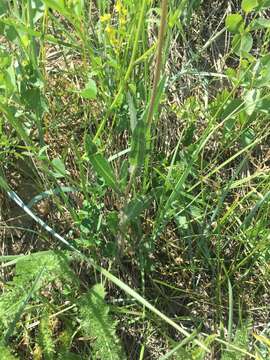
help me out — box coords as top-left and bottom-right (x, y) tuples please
(129, 119), (147, 171)
